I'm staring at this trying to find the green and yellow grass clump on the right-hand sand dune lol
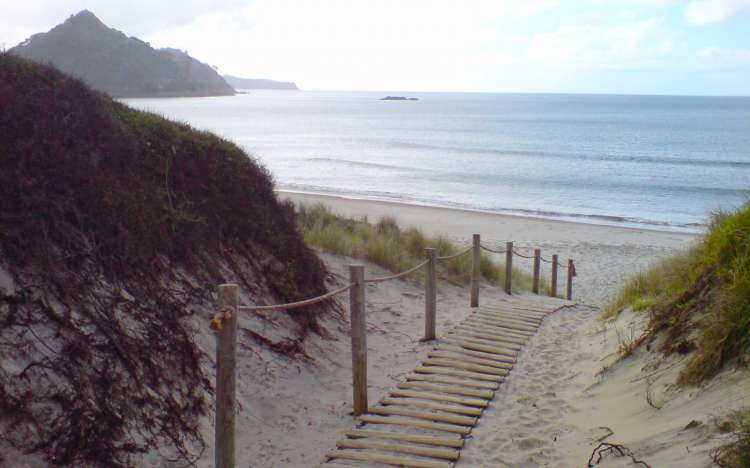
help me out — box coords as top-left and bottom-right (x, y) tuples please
(603, 203), (750, 384)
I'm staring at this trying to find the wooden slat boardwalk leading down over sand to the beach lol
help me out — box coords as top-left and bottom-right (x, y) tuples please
(321, 295), (572, 468)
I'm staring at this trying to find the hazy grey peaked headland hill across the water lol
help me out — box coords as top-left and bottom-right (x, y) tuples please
(10, 10), (234, 97)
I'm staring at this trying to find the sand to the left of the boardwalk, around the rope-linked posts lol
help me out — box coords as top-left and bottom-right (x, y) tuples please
(192, 254), (505, 468)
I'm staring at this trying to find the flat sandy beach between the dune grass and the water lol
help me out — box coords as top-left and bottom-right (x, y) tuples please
(279, 192), (697, 306)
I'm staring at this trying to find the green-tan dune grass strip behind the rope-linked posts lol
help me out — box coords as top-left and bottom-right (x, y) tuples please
(297, 204), (547, 292)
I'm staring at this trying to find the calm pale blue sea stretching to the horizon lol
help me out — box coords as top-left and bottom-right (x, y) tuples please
(125, 91), (750, 231)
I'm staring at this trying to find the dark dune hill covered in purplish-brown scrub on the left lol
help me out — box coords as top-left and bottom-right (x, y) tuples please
(0, 54), (330, 466)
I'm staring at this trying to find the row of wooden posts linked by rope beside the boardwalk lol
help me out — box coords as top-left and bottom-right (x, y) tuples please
(211, 234), (576, 468)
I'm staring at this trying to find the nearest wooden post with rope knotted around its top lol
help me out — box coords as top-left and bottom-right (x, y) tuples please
(214, 284), (240, 468)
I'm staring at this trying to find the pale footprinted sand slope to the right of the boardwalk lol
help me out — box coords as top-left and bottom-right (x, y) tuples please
(458, 308), (750, 467)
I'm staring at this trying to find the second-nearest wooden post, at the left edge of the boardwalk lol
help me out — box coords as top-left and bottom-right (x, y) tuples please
(349, 265), (367, 416)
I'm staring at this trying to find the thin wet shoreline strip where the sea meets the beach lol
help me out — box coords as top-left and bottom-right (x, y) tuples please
(274, 189), (705, 237)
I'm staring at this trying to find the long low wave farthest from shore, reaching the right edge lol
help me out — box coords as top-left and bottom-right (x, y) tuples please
(389, 141), (750, 169)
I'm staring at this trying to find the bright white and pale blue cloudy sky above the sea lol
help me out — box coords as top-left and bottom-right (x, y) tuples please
(0, 0), (750, 96)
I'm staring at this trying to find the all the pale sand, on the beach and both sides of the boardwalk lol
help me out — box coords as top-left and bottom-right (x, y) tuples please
(189, 194), (750, 467)
